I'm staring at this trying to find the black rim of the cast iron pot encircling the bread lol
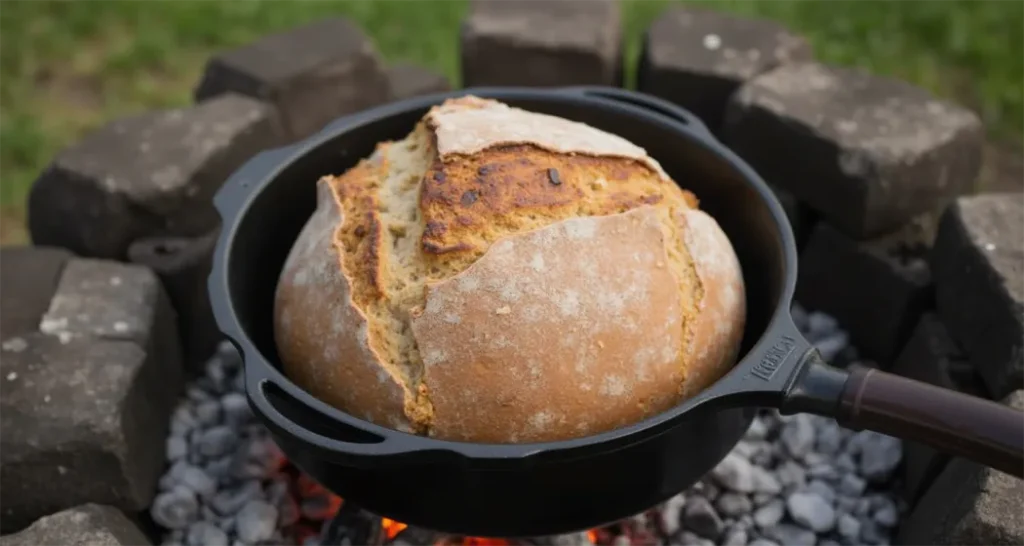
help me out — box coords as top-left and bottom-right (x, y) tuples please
(208, 87), (797, 461)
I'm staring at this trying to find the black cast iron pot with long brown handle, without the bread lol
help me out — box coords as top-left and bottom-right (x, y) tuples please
(209, 87), (1024, 537)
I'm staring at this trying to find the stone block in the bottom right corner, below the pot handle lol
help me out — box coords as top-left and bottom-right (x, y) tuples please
(896, 391), (1024, 546)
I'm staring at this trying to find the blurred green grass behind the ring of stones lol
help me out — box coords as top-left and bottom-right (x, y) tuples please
(0, 0), (1024, 242)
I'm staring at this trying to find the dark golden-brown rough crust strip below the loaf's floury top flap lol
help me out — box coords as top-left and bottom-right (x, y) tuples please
(421, 144), (696, 257)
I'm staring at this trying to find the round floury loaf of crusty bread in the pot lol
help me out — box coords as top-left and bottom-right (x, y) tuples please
(274, 96), (745, 444)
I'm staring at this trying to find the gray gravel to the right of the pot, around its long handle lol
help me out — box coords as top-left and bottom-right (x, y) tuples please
(662, 307), (904, 546)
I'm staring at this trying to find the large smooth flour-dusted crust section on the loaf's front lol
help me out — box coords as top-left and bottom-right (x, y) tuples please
(413, 207), (683, 443)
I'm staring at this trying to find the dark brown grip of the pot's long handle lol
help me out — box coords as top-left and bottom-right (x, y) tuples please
(836, 367), (1024, 478)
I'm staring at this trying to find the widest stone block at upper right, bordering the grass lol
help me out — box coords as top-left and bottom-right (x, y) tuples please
(722, 62), (984, 240)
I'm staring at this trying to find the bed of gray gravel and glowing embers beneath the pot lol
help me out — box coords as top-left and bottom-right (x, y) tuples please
(150, 307), (903, 546)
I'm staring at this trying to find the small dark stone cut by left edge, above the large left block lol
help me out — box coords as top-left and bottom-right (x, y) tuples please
(0, 246), (73, 333)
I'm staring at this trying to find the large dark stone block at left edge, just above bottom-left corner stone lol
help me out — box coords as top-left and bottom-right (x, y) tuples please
(0, 333), (174, 532)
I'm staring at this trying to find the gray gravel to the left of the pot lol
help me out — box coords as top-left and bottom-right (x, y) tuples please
(150, 343), (286, 546)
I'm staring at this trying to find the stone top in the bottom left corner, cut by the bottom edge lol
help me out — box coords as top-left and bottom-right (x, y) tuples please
(0, 504), (153, 546)
